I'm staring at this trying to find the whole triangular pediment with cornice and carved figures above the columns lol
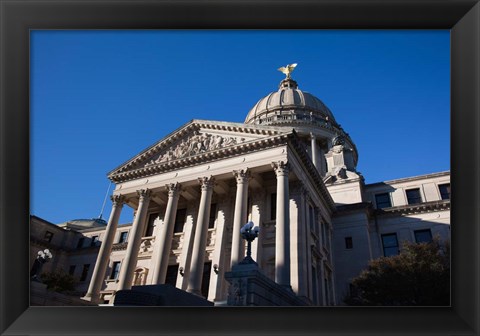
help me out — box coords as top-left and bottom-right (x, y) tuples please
(109, 120), (291, 181)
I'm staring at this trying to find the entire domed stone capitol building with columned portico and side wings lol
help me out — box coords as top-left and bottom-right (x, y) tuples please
(31, 67), (450, 306)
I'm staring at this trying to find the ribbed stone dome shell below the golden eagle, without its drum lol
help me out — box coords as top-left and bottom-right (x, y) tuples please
(245, 78), (336, 125)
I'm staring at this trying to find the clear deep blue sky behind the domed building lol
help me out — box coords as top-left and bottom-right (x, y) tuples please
(30, 30), (450, 223)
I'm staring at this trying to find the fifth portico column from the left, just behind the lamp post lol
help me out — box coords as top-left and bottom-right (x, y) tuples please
(230, 169), (250, 266)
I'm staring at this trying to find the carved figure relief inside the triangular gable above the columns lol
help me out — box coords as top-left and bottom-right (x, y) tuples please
(145, 131), (240, 167)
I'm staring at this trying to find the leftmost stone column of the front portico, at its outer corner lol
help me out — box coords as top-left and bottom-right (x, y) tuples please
(82, 195), (125, 302)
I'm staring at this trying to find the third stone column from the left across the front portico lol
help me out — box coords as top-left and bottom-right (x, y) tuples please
(153, 183), (181, 284)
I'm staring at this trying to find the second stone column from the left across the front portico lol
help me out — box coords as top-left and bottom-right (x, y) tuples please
(117, 189), (151, 290)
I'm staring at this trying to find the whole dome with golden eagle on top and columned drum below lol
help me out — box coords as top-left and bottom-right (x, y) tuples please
(245, 63), (358, 179)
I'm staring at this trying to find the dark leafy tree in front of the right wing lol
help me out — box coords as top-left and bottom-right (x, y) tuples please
(345, 238), (450, 306)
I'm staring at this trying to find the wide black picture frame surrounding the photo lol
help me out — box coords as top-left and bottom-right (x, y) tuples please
(0, 0), (480, 335)
